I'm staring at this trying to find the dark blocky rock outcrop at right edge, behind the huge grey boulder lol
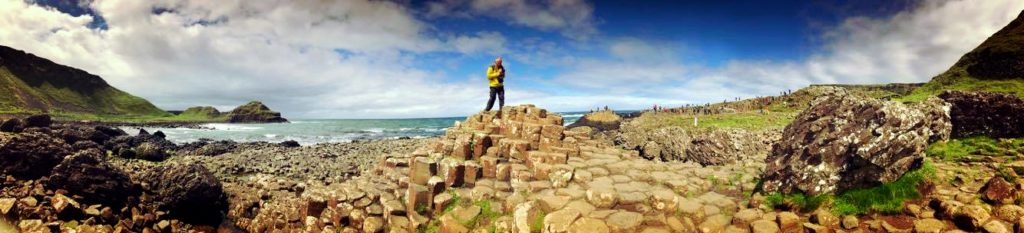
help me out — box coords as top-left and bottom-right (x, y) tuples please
(939, 91), (1024, 138)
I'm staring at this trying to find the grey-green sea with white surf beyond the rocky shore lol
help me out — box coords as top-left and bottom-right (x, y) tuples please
(123, 112), (586, 145)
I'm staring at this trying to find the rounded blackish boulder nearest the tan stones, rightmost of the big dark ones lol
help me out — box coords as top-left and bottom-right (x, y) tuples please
(144, 164), (227, 225)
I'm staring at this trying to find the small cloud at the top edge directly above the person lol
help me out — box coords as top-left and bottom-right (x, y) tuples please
(426, 0), (597, 39)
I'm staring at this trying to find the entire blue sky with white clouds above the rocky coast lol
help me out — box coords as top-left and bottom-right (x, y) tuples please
(0, 0), (1024, 119)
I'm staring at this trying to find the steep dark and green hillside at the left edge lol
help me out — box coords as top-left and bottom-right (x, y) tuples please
(0, 46), (168, 119)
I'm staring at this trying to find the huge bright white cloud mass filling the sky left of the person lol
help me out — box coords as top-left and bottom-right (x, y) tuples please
(0, 0), (504, 118)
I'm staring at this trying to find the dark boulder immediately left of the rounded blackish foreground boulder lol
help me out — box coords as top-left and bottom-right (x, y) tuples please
(45, 148), (135, 208)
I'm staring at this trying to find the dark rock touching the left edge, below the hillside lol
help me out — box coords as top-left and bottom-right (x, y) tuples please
(0, 133), (71, 180)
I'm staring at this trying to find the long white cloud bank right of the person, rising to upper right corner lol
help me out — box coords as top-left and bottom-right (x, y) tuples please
(555, 0), (1024, 104)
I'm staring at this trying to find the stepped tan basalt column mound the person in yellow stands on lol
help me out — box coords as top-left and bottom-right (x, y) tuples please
(228, 105), (778, 232)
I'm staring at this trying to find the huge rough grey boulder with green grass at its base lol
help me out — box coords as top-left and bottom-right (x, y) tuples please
(762, 90), (943, 195)
